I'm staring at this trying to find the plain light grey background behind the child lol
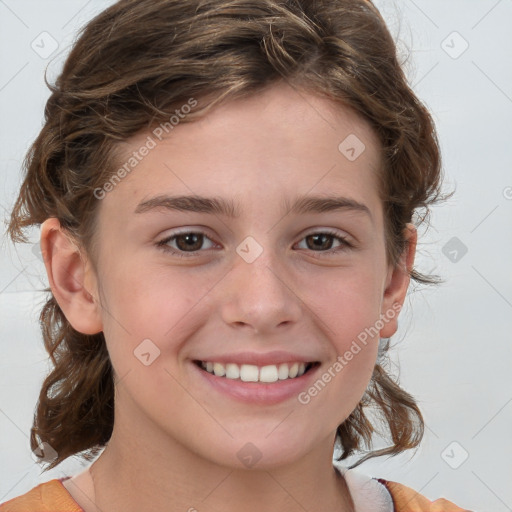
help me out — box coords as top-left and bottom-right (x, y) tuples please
(0, 0), (512, 512)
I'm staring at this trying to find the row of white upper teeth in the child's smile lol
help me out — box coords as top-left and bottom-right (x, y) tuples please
(201, 361), (306, 382)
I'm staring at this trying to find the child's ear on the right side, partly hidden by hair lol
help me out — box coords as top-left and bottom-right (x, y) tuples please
(380, 223), (418, 338)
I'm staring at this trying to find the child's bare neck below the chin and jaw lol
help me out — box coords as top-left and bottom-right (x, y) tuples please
(81, 420), (354, 512)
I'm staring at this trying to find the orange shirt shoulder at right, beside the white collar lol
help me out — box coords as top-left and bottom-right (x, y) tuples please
(377, 478), (470, 512)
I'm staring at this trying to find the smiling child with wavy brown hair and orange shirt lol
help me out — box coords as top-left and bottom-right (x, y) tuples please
(0, 0), (472, 512)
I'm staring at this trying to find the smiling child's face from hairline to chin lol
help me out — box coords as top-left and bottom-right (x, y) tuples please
(80, 82), (408, 467)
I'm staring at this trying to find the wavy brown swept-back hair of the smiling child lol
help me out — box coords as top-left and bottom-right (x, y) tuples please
(8, 0), (443, 469)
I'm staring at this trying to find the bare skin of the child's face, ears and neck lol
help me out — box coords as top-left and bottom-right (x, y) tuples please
(41, 85), (416, 512)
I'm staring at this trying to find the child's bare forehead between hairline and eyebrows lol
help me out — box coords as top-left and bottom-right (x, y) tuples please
(102, 85), (381, 219)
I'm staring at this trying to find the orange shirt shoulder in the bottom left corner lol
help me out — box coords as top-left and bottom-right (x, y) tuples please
(0, 478), (83, 512)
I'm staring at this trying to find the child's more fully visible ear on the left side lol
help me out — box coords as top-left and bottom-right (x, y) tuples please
(41, 217), (103, 334)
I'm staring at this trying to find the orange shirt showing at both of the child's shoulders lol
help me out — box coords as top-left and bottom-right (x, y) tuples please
(0, 478), (469, 512)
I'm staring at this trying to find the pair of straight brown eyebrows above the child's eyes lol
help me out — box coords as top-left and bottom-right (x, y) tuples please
(135, 195), (372, 219)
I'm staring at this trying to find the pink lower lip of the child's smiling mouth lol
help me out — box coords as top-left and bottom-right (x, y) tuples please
(192, 363), (320, 405)
